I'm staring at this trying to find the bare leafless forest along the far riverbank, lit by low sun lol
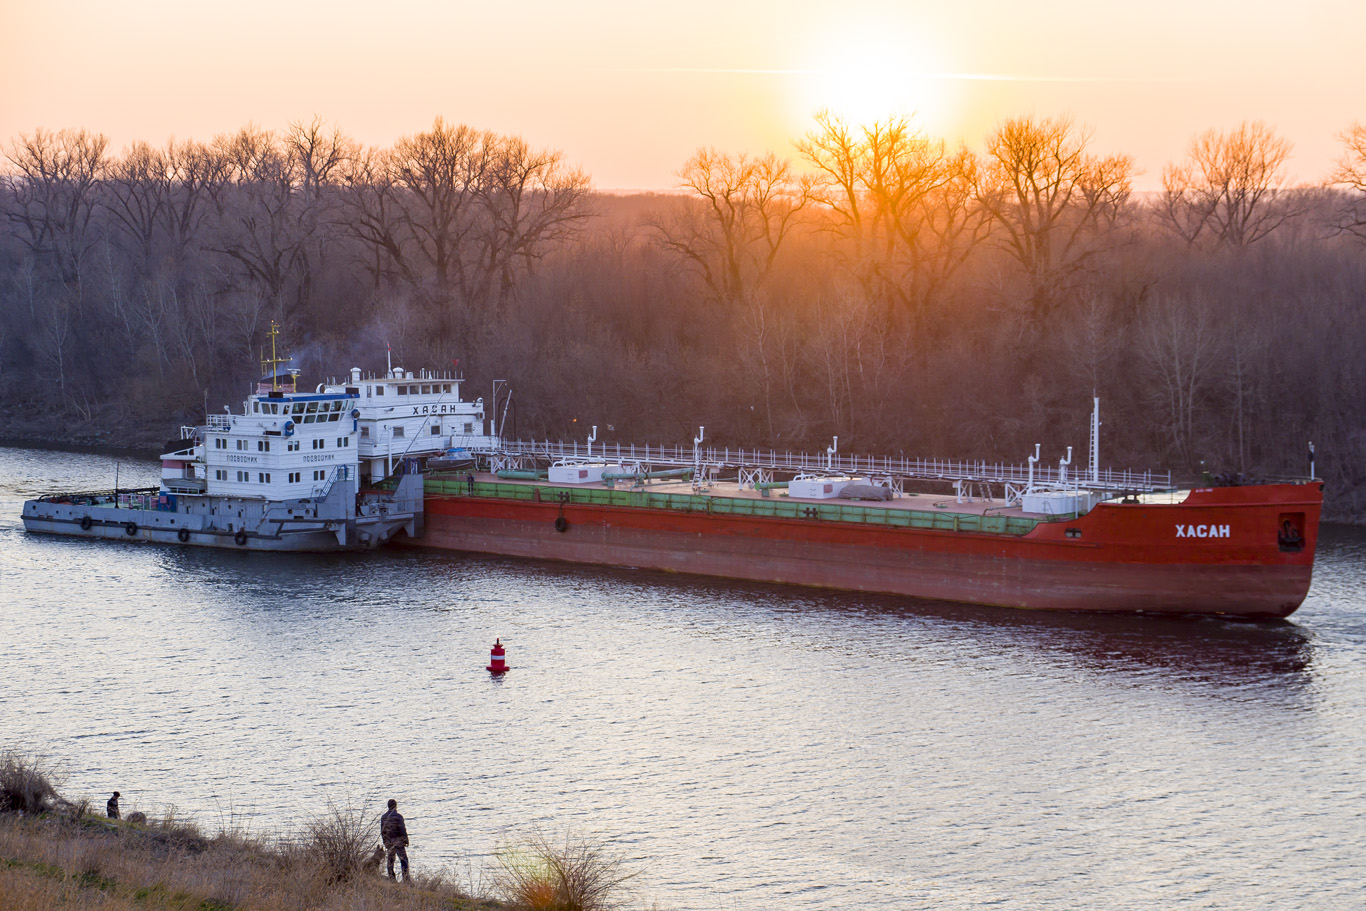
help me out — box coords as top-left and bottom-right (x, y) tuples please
(8, 113), (1366, 520)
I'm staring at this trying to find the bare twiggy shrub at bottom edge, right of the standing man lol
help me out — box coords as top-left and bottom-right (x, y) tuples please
(493, 832), (635, 911)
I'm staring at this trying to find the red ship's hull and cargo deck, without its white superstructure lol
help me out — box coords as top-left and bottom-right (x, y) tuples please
(413, 417), (1322, 619)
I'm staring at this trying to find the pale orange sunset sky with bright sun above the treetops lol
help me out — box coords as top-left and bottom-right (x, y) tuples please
(0, 0), (1366, 188)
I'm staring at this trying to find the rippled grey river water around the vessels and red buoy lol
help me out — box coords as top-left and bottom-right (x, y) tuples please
(0, 449), (1366, 911)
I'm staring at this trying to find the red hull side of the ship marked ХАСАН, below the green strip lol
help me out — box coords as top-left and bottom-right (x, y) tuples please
(411, 483), (1321, 619)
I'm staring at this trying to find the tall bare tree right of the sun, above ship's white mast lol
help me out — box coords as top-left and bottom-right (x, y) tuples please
(975, 117), (1134, 317)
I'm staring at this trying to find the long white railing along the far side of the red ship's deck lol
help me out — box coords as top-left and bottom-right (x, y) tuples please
(486, 440), (1172, 492)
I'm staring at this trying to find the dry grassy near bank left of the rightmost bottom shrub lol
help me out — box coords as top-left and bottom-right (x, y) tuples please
(0, 753), (499, 911)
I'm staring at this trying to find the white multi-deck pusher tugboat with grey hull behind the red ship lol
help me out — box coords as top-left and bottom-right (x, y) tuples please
(23, 325), (422, 550)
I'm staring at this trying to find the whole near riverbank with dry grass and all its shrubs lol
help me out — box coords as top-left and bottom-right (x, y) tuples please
(0, 753), (631, 911)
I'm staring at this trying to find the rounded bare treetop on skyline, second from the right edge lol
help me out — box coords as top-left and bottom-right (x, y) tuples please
(1157, 122), (1298, 247)
